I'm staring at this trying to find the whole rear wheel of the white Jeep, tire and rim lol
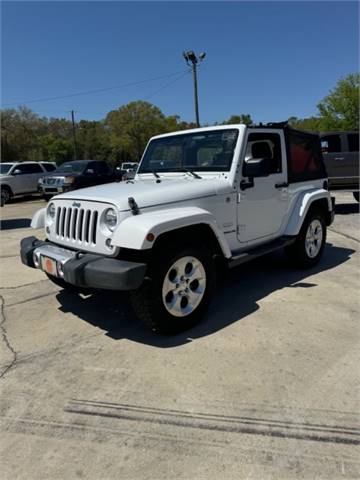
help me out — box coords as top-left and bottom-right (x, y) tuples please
(286, 211), (326, 267)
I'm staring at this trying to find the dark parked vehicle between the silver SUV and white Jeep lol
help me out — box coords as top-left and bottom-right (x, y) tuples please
(39, 160), (117, 200)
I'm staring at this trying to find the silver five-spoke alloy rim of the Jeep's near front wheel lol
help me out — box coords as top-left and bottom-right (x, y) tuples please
(162, 256), (206, 317)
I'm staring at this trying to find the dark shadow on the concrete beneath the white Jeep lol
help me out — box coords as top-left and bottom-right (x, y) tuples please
(56, 244), (355, 348)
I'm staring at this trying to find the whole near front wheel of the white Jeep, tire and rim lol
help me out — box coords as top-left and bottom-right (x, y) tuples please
(131, 247), (215, 334)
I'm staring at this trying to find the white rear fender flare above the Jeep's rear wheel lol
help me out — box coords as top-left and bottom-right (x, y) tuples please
(284, 188), (332, 236)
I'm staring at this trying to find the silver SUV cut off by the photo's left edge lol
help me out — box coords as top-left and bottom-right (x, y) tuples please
(0, 162), (56, 207)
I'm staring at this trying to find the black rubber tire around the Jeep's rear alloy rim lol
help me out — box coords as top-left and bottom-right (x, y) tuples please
(285, 210), (326, 268)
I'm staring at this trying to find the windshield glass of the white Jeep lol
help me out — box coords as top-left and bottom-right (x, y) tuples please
(138, 129), (239, 173)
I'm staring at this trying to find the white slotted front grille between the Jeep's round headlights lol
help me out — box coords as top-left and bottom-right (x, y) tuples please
(55, 207), (99, 246)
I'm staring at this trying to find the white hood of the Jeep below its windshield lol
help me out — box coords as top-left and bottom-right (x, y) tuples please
(54, 177), (230, 211)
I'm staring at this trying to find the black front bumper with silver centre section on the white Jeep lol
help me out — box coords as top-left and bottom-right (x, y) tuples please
(20, 237), (146, 290)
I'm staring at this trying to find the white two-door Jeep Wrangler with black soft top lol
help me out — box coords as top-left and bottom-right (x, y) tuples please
(21, 123), (334, 333)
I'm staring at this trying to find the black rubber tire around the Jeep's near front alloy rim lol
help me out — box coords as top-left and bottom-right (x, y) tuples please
(131, 247), (216, 334)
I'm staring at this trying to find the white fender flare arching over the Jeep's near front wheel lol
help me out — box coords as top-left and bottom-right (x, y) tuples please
(112, 207), (231, 258)
